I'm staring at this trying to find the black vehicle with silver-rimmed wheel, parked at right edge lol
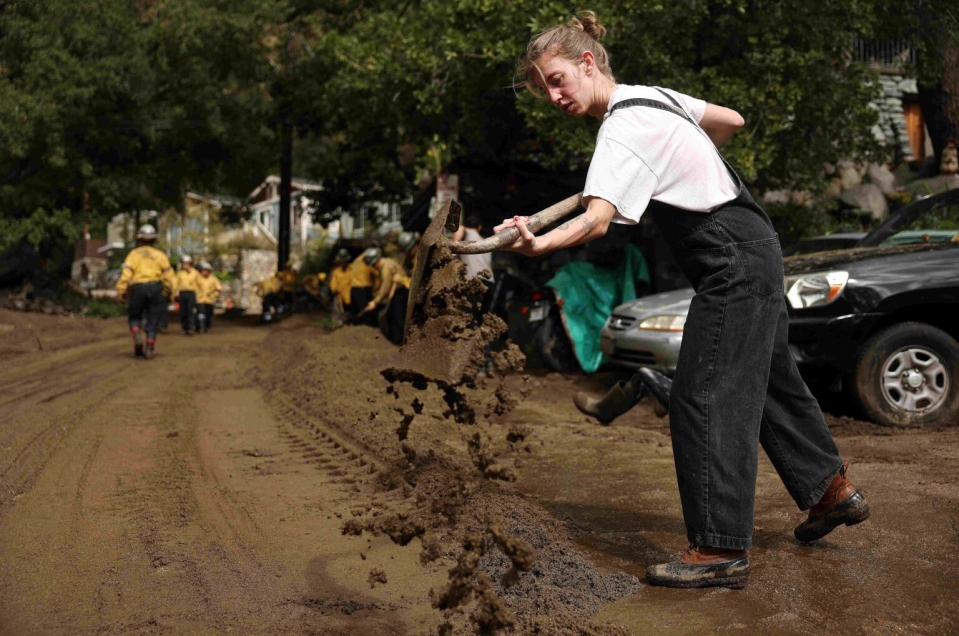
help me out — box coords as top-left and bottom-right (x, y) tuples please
(784, 190), (959, 426)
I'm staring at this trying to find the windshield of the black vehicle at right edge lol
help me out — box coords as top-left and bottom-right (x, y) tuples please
(860, 192), (959, 246)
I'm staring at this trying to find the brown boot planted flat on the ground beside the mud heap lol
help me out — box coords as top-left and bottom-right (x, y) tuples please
(646, 546), (749, 590)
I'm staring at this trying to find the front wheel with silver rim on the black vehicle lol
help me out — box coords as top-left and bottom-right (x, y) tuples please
(852, 322), (959, 426)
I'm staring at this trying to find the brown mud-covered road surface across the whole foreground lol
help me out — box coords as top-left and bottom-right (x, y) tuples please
(0, 311), (959, 634)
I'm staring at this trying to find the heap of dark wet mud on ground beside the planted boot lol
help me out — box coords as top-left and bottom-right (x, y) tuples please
(433, 492), (640, 634)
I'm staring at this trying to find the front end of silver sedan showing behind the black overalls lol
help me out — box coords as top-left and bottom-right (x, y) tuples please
(600, 288), (694, 375)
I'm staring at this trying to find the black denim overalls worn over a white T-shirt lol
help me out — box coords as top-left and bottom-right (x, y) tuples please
(612, 93), (842, 550)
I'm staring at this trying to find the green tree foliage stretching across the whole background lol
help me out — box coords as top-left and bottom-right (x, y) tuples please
(0, 0), (956, 258)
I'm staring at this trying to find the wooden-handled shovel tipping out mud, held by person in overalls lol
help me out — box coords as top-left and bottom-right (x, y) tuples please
(403, 192), (583, 342)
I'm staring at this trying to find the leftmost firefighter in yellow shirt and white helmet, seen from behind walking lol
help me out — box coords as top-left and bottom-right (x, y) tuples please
(117, 224), (176, 360)
